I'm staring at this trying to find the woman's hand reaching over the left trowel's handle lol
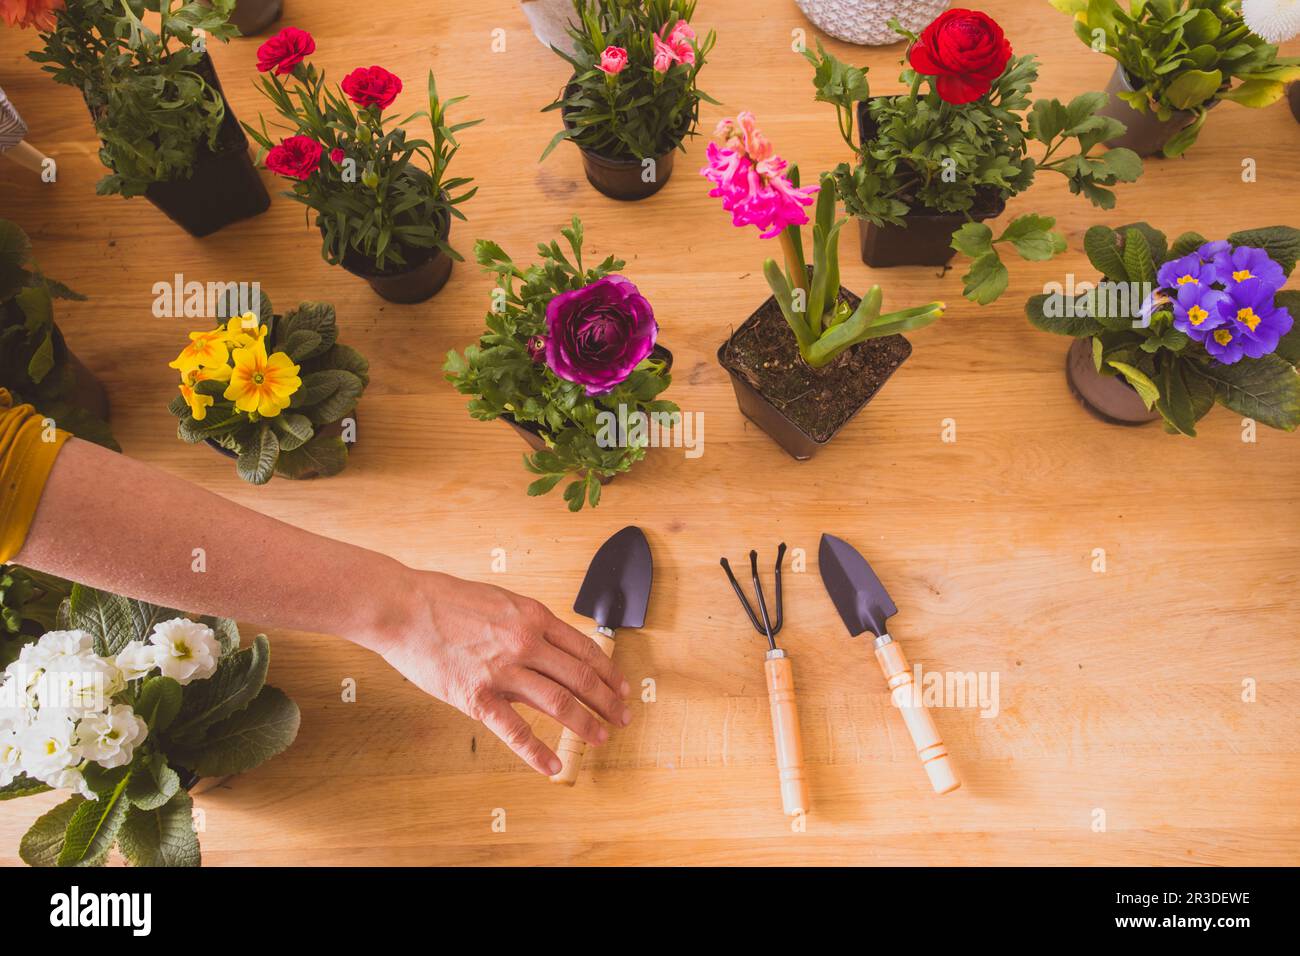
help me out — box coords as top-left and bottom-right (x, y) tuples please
(365, 571), (632, 775)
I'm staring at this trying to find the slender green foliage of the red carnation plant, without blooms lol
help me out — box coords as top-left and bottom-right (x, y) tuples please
(243, 62), (482, 273)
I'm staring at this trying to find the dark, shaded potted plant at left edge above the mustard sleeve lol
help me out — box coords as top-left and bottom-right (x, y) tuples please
(0, 220), (121, 451)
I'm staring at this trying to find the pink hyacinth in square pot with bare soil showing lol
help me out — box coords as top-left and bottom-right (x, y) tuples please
(701, 112), (944, 460)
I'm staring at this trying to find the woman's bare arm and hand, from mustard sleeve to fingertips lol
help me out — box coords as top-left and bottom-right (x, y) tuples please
(14, 438), (632, 774)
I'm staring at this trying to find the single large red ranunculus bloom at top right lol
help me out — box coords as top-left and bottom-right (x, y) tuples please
(907, 9), (1011, 104)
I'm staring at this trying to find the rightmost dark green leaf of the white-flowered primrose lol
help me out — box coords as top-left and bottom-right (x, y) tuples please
(167, 686), (297, 777)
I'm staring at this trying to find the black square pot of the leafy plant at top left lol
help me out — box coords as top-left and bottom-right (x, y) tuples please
(128, 53), (270, 237)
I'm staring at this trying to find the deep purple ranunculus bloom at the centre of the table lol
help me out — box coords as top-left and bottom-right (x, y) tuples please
(546, 276), (659, 395)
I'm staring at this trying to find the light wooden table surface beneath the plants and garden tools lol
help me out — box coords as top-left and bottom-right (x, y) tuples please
(0, 0), (1300, 865)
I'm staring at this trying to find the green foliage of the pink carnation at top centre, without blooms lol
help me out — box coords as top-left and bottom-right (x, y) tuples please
(542, 0), (718, 160)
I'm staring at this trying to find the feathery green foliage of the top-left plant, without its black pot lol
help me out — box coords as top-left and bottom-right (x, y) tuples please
(29, 0), (239, 196)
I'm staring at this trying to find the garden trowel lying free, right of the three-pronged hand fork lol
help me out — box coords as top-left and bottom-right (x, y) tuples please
(818, 535), (961, 793)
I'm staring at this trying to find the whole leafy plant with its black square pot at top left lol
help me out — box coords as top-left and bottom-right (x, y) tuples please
(29, 0), (270, 235)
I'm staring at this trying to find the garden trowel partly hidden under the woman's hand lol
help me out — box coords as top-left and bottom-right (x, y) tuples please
(551, 524), (653, 787)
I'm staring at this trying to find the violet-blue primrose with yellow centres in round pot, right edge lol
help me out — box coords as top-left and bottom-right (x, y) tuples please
(1026, 222), (1300, 436)
